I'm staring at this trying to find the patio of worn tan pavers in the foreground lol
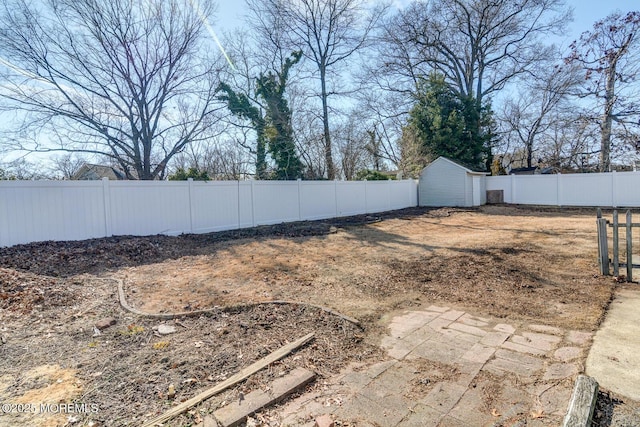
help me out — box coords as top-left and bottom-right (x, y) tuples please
(272, 306), (592, 427)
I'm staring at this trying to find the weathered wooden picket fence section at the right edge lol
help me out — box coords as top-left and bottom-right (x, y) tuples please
(596, 209), (640, 282)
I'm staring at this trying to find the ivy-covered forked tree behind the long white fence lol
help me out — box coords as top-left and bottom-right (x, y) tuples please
(220, 52), (303, 180)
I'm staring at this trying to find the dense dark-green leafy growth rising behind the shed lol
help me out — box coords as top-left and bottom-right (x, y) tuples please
(405, 73), (495, 170)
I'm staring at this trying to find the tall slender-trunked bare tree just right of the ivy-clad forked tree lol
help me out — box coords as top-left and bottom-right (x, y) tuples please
(246, 0), (384, 179)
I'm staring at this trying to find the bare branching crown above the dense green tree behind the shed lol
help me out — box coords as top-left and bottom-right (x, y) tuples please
(378, 0), (570, 109)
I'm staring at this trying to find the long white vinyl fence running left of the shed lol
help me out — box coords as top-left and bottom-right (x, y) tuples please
(0, 179), (418, 247)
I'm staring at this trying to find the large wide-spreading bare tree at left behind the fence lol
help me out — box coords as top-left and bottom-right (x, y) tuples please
(0, 0), (222, 179)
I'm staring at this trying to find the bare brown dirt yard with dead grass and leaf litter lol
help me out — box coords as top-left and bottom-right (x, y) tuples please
(0, 206), (628, 426)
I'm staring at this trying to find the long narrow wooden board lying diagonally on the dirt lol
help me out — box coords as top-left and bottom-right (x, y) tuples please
(142, 332), (314, 427)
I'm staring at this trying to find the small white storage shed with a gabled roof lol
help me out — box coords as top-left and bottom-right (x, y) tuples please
(418, 157), (488, 207)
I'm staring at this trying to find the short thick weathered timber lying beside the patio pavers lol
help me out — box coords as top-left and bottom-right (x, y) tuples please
(213, 368), (316, 427)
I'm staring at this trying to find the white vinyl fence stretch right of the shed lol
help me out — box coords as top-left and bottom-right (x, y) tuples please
(486, 172), (640, 207)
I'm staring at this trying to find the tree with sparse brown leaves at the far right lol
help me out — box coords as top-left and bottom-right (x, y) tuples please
(567, 12), (640, 172)
